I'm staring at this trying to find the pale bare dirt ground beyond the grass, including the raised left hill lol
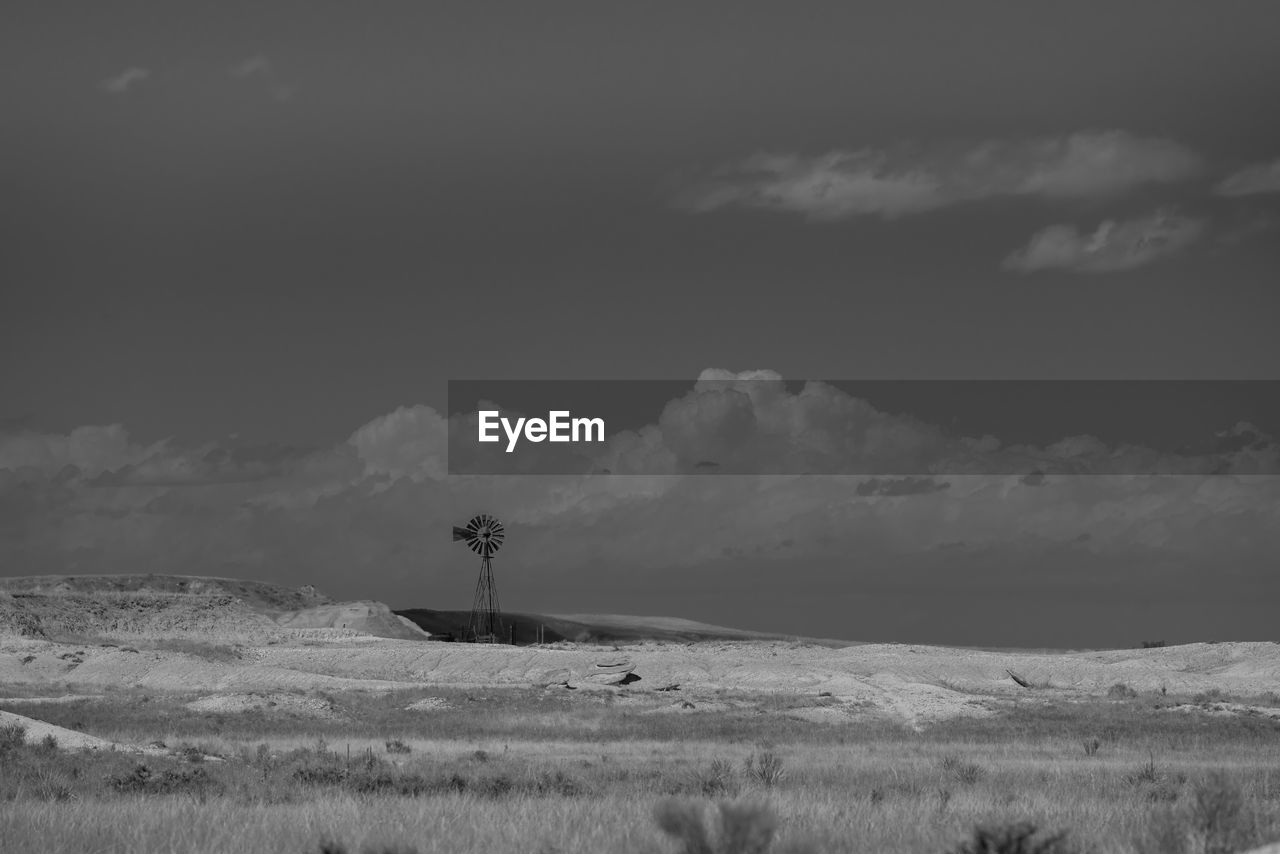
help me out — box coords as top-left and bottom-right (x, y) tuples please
(0, 576), (1280, 729)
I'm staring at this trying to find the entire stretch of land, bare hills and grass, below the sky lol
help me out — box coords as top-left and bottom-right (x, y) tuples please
(0, 576), (1280, 854)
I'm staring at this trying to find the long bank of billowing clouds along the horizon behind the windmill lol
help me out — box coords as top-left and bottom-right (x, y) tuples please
(0, 371), (1280, 635)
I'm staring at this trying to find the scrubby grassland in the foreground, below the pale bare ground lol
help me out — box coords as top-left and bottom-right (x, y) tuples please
(0, 689), (1280, 854)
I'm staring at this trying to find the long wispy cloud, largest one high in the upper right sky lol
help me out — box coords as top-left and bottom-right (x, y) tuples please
(676, 131), (1199, 220)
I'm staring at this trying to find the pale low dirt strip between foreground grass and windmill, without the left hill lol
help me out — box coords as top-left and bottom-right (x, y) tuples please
(0, 630), (1280, 726)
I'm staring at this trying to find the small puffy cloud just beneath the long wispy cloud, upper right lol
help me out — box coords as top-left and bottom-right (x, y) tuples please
(1002, 210), (1206, 273)
